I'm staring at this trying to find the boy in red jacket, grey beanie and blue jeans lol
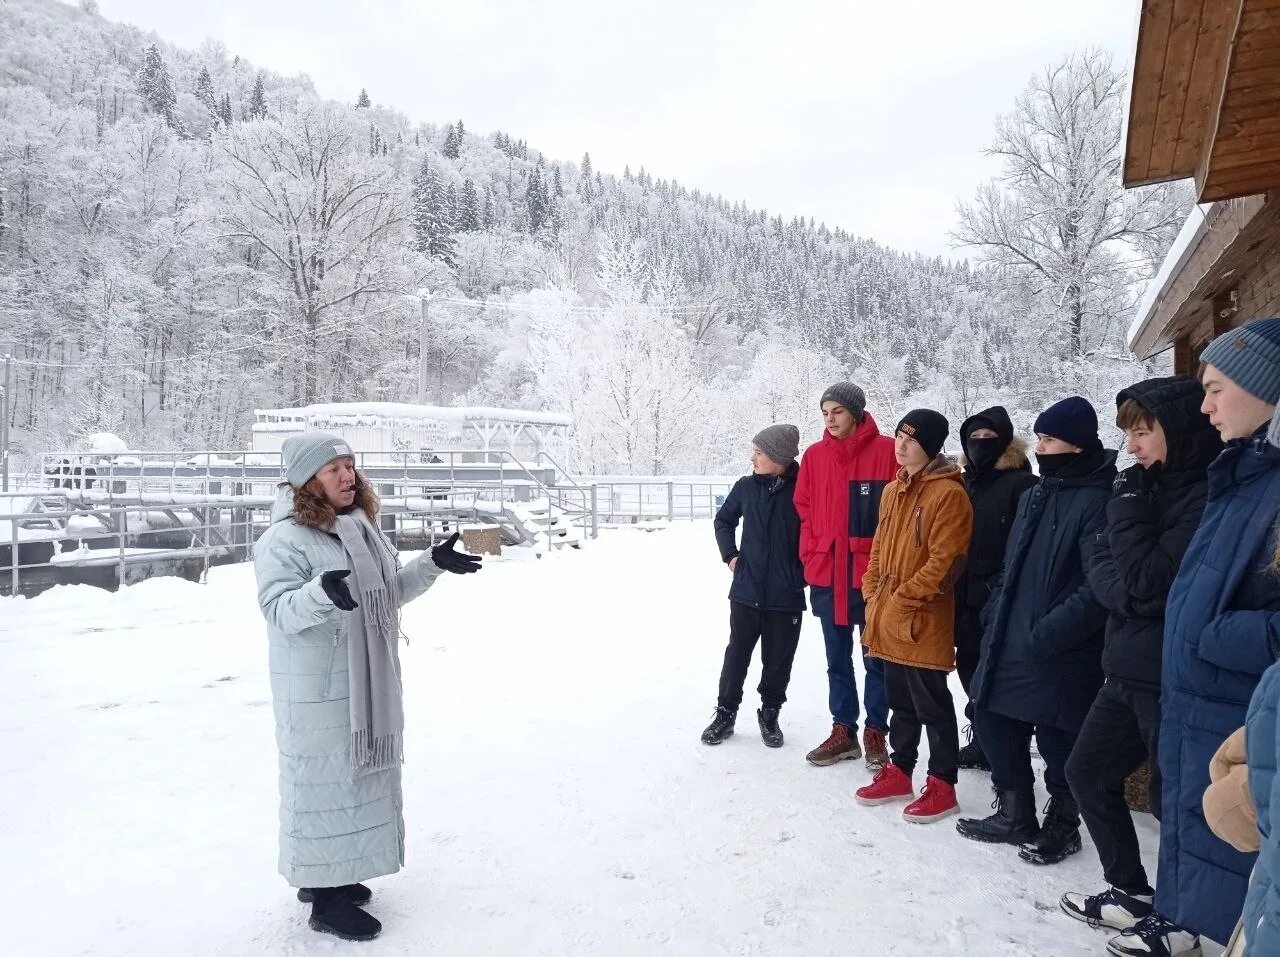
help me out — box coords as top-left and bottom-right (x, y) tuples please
(795, 383), (899, 768)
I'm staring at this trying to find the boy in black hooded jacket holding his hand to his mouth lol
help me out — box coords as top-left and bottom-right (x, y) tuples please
(1060, 377), (1222, 930)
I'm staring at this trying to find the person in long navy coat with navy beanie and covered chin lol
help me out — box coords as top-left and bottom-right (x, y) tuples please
(956, 395), (1116, 864)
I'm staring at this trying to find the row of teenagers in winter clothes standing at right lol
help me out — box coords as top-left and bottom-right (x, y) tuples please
(703, 319), (1280, 957)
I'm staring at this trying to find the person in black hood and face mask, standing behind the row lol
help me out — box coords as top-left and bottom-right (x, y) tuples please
(956, 406), (1036, 770)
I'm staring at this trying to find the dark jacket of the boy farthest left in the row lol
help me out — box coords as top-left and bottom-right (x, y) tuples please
(714, 462), (805, 612)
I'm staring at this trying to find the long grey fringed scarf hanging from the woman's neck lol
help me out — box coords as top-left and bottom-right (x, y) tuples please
(332, 509), (404, 775)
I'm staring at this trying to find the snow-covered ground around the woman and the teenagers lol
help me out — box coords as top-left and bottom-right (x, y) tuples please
(0, 522), (1156, 957)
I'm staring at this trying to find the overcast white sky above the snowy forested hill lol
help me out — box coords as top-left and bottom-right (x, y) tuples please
(100, 0), (1138, 255)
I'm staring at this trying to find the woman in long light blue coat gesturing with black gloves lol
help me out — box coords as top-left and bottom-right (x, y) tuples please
(253, 432), (480, 940)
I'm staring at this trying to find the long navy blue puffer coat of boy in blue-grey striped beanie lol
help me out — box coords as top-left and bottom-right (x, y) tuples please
(1156, 430), (1280, 943)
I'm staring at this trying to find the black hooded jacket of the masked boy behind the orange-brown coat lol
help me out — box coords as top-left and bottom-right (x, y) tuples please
(956, 406), (1036, 614)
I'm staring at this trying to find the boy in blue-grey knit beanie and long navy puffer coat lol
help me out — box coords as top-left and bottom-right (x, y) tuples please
(1107, 319), (1280, 957)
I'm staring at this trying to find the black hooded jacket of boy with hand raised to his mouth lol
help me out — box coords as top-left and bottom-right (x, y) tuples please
(1088, 377), (1222, 690)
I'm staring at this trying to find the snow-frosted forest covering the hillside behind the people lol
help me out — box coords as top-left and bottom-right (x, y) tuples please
(0, 0), (1190, 473)
